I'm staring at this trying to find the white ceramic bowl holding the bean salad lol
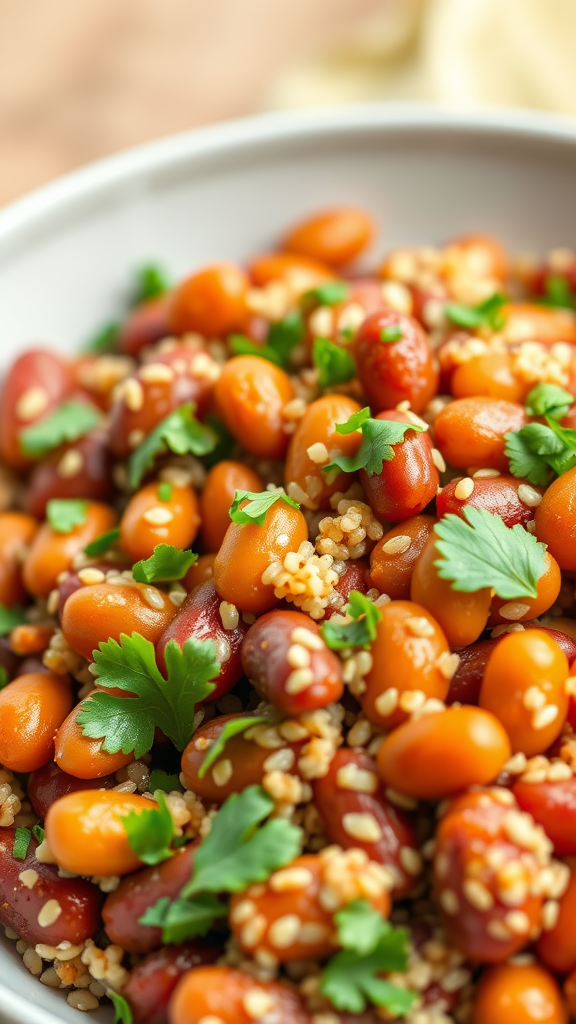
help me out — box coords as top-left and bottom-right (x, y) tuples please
(0, 104), (576, 1024)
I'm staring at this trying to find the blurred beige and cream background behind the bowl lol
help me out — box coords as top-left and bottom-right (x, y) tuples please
(0, 0), (576, 205)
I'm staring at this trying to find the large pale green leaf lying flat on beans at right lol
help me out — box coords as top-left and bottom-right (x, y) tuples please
(434, 505), (546, 601)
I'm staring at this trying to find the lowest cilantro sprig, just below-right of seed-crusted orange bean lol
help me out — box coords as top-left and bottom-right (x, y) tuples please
(321, 900), (416, 1018)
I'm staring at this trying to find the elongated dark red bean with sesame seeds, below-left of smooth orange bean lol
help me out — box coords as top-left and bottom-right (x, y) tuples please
(313, 750), (422, 896)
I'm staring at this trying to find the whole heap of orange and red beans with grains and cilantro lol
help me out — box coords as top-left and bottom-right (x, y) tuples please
(0, 208), (576, 1024)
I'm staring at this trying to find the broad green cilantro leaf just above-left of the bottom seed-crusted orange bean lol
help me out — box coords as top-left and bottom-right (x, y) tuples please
(180, 785), (301, 898)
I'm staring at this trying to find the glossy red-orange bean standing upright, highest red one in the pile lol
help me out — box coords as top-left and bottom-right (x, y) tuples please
(355, 309), (438, 415)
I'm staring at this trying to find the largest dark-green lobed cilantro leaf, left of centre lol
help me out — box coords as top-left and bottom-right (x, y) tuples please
(78, 633), (220, 759)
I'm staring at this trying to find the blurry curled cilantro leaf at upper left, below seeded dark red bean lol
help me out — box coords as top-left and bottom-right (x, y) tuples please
(128, 402), (217, 490)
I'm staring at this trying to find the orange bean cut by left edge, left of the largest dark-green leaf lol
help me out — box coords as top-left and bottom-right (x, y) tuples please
(0, 672), (72, 772)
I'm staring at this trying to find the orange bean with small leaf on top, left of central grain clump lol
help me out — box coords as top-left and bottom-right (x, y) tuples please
(214, 501), (308, 615)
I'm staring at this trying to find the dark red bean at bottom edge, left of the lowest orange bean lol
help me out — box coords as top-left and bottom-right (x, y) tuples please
(122, 942), (222, 1024)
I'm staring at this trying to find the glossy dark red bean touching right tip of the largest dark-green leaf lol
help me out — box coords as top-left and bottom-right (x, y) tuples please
(156, 580), (248, 700)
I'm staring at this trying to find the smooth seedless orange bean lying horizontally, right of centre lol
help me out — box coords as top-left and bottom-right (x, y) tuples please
(377, 707), (510, 800)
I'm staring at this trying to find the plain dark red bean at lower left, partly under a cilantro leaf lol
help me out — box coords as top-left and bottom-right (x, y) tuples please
(102, 843), (198, 953)
